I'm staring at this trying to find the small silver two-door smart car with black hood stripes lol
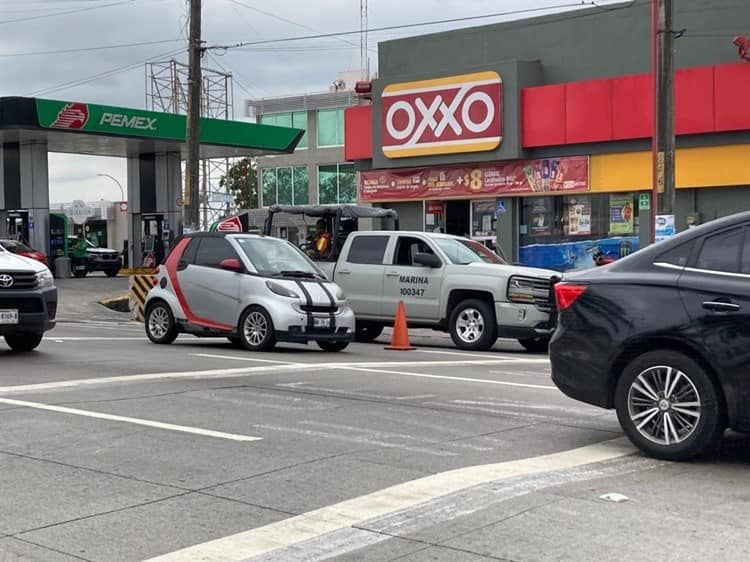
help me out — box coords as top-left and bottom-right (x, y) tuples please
(145, 233), (354, 351)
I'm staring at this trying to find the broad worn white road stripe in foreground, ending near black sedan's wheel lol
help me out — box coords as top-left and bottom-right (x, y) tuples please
(147, 438), (635, 562)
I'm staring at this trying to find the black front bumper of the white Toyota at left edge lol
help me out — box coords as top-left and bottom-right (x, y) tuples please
(0, 287), (57, 336)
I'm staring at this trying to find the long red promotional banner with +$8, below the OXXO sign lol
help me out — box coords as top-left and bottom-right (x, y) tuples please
(359, 156), (589, 201)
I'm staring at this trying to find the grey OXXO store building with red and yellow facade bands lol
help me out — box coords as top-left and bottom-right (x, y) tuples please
(345, 0), (750, 271)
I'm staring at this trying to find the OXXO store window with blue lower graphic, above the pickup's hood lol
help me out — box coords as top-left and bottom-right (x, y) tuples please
(520, 193), (639, 271)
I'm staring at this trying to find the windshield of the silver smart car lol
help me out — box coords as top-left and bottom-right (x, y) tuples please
(236, 238), (325, 278)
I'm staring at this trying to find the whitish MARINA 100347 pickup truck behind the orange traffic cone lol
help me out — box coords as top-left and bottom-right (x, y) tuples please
(318, 231), (556, 351)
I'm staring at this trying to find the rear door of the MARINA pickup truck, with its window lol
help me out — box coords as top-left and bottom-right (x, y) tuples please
(334, 234), (391, 318)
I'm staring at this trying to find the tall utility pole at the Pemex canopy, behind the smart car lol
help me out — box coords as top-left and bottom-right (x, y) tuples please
(185, 0), (203, 230)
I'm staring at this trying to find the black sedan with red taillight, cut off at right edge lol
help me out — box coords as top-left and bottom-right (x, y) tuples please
(550, 212), (750, 460)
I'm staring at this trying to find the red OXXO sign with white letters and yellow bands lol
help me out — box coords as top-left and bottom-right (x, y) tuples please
(382, 72), (502, 158)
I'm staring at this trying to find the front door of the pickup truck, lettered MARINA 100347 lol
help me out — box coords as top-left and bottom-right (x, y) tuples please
(385, 236), (445, 322)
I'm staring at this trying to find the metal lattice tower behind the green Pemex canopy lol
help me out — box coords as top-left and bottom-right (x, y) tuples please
(146, 59), (234, 229)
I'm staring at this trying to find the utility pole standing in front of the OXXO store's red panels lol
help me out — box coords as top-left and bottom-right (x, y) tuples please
(652, 0), (675, 233)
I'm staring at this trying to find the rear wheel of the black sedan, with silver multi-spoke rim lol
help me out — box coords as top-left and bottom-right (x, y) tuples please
(615, 351), (725, 460)
